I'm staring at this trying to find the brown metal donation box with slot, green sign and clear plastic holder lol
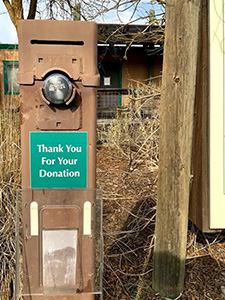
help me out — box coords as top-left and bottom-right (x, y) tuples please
(16, 20), (102, 300)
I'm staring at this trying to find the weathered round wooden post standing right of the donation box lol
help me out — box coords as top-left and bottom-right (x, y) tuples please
(153, 0), (202, 298)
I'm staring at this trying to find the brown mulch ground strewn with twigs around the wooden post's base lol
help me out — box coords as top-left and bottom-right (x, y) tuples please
(97, 147), (225, 300)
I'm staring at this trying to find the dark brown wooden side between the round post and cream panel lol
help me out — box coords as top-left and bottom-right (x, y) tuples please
(189, 0), (212, 232)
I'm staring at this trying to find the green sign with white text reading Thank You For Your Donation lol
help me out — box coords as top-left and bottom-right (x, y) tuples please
(30, 132), (87, 188)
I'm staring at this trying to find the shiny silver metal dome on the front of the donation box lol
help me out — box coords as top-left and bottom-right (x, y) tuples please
(42, 73), (73, 104)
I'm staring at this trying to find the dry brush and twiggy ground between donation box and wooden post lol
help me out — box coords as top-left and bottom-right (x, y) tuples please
(97, 88), (159, 300)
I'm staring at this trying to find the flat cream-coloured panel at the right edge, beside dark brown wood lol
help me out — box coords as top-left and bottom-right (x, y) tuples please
(210, 0), (225, 229)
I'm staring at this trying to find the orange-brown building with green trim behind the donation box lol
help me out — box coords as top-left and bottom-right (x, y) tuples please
(0, 24), (163, 118)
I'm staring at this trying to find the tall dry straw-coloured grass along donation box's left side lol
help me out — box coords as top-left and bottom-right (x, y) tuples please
(0, 96), (21, 300)
